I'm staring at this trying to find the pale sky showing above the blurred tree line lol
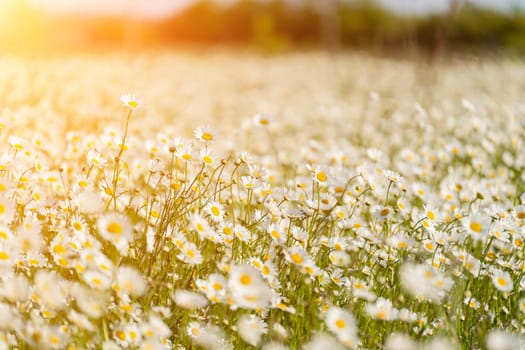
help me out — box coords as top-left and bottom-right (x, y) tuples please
(18, 0), (525, 19)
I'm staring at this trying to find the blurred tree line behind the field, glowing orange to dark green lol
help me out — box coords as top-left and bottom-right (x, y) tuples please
(5, 0), (525, 57)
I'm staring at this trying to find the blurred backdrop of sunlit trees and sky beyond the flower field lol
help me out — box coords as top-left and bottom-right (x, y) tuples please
(0, 0), (525, 57)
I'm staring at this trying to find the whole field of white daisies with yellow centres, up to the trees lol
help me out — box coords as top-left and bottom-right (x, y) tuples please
(0, 51), (525, 350)
